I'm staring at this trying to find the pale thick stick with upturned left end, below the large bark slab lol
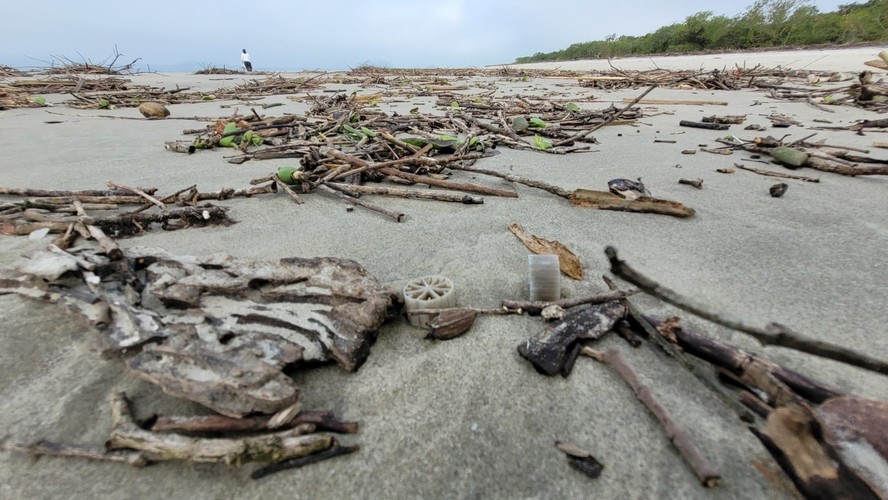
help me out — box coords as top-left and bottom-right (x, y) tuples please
(105, 393), (333, 467)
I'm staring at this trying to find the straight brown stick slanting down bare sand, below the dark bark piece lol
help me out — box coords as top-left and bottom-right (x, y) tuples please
(580, 347), (721, 488)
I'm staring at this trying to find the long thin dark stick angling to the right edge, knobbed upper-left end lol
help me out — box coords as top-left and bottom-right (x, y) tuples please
(604, 246), (888, 375)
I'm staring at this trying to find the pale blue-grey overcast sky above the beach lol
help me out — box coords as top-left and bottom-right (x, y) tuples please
(0, 0), (848, 71)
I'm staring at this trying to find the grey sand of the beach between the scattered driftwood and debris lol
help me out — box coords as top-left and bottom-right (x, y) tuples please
(0, 48), (888, 499)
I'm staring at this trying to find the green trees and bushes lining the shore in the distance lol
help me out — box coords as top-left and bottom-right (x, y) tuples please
(515, 0), (888, 63)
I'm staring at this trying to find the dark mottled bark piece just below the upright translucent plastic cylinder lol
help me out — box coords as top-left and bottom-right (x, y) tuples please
(518, 301), (626, 376)
